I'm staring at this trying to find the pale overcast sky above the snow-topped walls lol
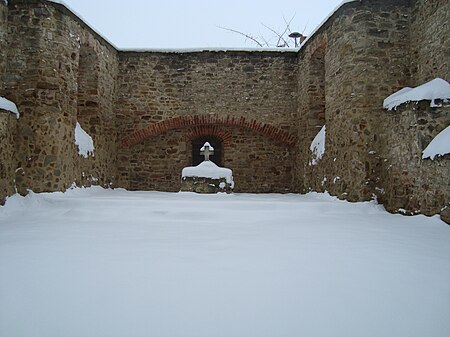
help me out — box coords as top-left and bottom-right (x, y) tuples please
(59, 0), (341, 48)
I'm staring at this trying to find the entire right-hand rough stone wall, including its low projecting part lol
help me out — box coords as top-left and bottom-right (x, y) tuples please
(297, 1), (450, 221)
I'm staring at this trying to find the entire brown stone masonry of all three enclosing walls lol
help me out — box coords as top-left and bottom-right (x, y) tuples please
(0, 0), (450, 222)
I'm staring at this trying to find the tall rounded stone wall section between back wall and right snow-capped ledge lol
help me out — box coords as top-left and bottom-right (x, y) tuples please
(299, 1), (410, 201)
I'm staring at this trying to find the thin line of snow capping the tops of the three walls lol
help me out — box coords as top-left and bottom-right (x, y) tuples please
(47, 0), (360, 53)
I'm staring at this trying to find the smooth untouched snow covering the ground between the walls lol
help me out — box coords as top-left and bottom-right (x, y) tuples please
(0, 188), (450, 337)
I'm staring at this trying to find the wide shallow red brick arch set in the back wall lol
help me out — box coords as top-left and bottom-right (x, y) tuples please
(122, 115), (297, 147)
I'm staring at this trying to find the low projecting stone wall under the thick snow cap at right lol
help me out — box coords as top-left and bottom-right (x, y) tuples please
(377, 101), (450, 222)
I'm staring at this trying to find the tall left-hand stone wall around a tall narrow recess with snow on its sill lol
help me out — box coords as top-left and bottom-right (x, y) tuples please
(4, 0), (117, 197)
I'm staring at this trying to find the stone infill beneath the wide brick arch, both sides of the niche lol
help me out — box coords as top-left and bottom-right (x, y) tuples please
(128, 128), (294, 193)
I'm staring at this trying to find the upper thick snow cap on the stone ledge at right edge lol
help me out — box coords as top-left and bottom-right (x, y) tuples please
(383, 78), (450, 110)
